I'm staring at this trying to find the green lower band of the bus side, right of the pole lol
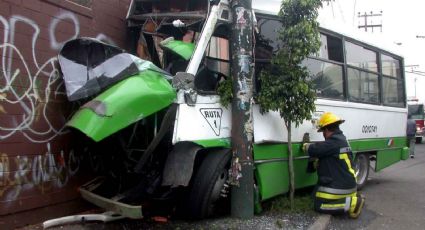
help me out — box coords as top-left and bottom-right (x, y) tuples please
(253, 137), (407, 200)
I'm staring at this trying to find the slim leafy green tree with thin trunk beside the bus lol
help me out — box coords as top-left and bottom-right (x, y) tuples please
(257, 0), (322, 208)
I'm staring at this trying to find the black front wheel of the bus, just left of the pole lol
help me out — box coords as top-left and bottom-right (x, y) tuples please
(188, 150), (231, 219)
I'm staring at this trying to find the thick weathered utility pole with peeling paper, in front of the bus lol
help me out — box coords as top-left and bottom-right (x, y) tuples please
(230, 0), (254, 219)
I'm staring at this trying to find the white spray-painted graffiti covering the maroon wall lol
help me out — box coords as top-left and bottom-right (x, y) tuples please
(0, 11), (114, 201)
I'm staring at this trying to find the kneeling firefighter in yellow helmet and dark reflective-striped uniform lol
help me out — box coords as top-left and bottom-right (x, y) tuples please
(303, 112), (365, 218)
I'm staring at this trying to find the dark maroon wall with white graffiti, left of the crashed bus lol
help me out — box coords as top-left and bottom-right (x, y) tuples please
(0, 0), (130, 215)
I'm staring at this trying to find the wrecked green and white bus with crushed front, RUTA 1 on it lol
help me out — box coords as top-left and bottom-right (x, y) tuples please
(59, 0), (408, 218)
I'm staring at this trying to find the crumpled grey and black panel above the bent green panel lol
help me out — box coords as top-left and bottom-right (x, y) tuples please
(58, 38), (171, 101)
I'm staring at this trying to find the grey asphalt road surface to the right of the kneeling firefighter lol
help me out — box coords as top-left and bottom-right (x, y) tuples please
(328, 144), (425, 230)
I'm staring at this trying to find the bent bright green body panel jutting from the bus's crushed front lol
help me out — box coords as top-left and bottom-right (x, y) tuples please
(67, 70), (176, 141)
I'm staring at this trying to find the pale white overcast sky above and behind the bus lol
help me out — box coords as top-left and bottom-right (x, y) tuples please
(252, 0), (425, 103)
